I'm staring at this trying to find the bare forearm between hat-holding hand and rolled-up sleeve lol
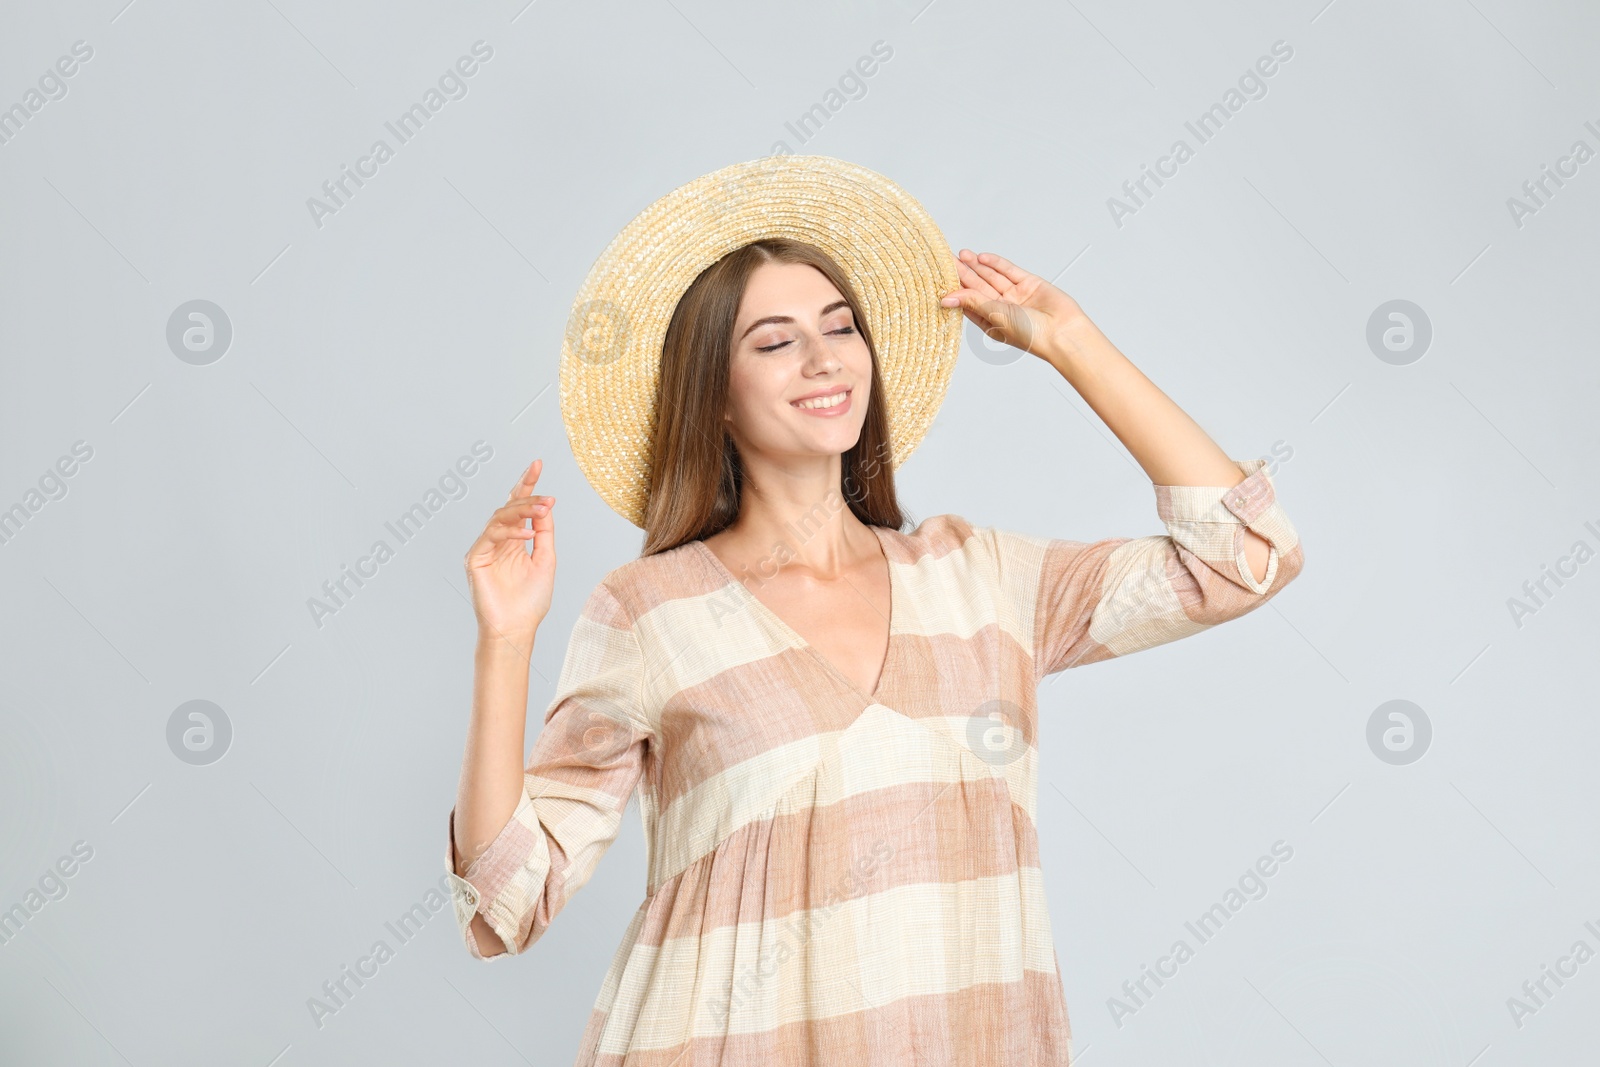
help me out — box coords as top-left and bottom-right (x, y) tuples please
(1043, 317), (1270, 581)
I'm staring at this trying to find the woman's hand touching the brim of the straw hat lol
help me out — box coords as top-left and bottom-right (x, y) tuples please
(939, 248), (1088, 363)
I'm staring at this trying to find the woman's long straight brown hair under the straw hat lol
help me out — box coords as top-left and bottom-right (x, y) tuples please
(640, 237), (906, 555)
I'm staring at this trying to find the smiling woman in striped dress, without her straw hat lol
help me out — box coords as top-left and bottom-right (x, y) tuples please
(446, 158), (1302, 1067)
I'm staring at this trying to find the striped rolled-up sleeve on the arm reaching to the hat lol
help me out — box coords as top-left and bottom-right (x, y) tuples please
(989, 459), (1304, 678)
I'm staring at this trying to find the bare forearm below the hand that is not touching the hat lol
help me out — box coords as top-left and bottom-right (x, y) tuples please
(454, 633), (533, 875)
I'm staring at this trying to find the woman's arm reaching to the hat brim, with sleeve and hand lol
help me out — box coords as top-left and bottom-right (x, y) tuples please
(942, 248), (1304, 677)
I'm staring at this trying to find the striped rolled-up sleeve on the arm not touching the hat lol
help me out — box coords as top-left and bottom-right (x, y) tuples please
(445, 582), (651, 960)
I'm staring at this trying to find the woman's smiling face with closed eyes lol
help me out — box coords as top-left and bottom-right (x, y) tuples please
(726, 262), (872, 459)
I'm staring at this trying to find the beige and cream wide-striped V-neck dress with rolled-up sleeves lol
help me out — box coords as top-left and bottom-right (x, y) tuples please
(445, 459), (1302, 1067)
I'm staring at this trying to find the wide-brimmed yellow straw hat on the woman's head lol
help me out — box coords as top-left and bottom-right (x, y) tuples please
(560, 155), (963, 528)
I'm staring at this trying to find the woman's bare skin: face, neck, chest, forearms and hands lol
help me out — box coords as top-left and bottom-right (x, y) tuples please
(454, 248), (1269, 955)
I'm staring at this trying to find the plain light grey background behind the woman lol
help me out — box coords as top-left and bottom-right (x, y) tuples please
(0, 0), (1600, 1067)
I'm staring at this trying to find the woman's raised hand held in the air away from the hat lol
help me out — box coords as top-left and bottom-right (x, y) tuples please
(466, 459), (555, 653)
